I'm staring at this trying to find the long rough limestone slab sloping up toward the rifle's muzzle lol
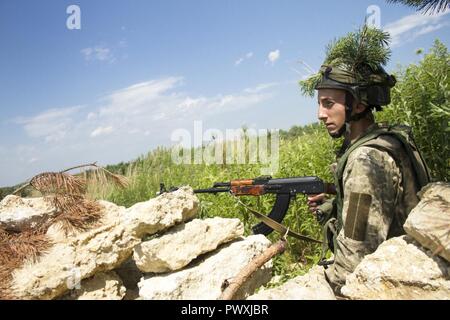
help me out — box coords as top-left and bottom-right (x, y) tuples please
(8, 188), (199, 299)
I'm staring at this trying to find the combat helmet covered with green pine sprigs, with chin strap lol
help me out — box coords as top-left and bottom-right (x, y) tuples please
(300, 25), (396, 134)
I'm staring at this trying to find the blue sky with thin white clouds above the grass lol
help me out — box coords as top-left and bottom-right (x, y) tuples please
(0, 0), (450, 186)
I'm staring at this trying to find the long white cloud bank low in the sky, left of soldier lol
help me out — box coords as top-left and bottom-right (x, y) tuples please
(16, 77), (278, 145)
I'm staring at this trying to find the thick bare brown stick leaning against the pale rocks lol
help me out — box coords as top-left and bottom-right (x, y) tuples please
(219, 239), (287, 300)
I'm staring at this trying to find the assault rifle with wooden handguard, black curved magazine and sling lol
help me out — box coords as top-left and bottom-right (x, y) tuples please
(159, 176), (336, 242)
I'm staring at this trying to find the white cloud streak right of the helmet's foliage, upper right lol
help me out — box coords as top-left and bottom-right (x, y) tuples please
(383, 10), (450, 47)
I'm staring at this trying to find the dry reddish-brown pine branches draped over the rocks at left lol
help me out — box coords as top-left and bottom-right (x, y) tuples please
(0, 163), (128, 299)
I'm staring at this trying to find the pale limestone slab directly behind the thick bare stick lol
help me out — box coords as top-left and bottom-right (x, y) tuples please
(138, 235), (272, 300)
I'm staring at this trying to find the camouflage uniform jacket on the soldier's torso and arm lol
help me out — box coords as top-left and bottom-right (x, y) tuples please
(318, 124), (428, 292)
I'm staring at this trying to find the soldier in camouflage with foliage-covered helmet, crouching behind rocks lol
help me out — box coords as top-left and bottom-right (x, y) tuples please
(300, 26), (429, 295)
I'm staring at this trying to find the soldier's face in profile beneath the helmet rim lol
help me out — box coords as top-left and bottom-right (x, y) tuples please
(317, 89), (345, 137)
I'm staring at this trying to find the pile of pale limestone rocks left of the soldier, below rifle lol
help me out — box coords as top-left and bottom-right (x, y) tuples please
(0, 188), (272, 299)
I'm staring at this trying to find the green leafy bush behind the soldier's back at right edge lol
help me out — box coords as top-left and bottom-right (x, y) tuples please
(377, 40), (450, 181)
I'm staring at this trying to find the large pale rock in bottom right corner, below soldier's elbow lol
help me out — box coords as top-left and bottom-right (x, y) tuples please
(341, 236), (450, 300)
